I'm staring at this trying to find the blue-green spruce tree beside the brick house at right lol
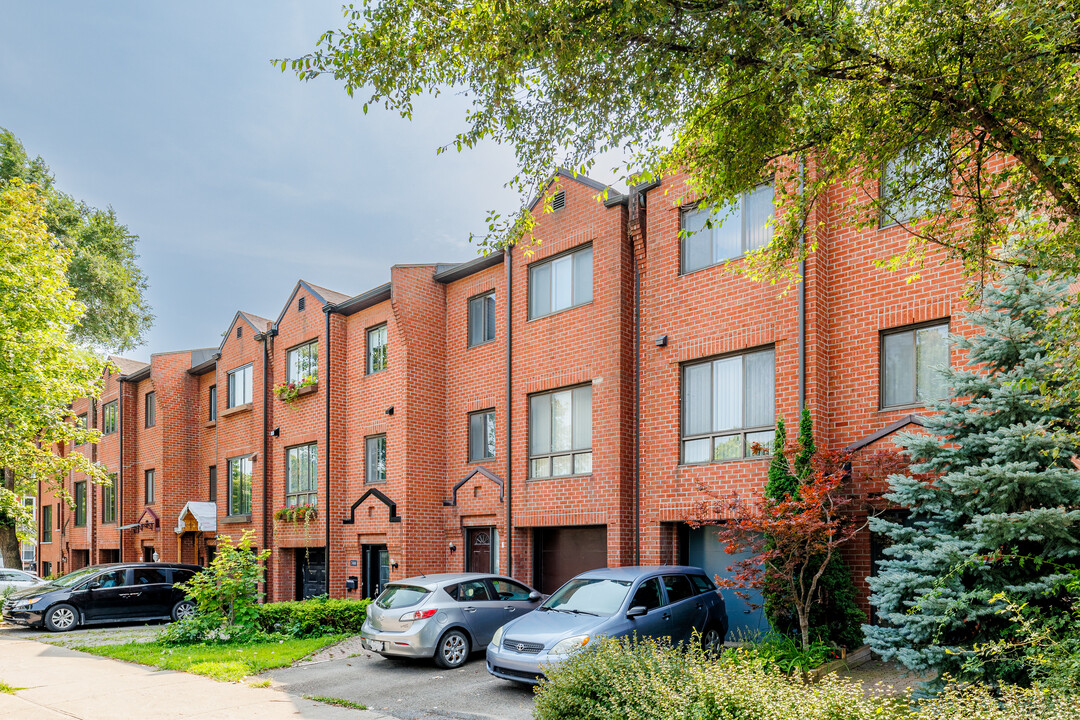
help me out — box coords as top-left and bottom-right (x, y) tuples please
(864, 271), (1080, 682)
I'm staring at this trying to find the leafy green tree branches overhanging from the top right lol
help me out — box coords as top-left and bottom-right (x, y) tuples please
(275, 0), (1080, 279)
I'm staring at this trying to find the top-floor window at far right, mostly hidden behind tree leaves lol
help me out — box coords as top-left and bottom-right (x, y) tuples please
(879, 141), (950, 228)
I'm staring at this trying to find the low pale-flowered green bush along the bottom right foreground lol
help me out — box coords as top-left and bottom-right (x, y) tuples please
(535, 639), (1080, 720)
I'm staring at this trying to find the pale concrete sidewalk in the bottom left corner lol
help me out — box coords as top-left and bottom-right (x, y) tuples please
(0, 636), (390, 720)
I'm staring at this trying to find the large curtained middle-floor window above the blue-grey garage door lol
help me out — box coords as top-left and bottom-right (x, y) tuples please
(683, 348), (775, 464)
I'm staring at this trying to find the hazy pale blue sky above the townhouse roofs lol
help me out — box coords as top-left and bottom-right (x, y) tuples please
(0, 0), (605, 361)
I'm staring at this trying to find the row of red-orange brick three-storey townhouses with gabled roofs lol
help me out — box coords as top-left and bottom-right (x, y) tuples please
(38, 166), (970, 627)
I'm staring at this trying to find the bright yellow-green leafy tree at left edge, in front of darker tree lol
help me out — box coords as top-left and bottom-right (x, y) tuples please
(0, 178), (107, 567)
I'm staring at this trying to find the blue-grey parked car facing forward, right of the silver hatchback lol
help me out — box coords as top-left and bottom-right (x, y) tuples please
(487, 566), (728, 683)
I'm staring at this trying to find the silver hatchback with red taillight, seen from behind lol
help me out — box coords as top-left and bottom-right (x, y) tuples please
(360, 572), (543, 667)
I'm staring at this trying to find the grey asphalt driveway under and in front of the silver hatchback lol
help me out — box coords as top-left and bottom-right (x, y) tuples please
(270, 651), (532, 720)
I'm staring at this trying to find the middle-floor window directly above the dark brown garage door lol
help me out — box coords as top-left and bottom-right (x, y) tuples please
(529, 385), (593, 477)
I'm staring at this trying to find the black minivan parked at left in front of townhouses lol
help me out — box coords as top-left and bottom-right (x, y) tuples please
(3, 562), (202, 633)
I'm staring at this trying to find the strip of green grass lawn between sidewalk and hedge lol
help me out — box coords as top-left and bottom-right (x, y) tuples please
(75, 635), (342, 682)
